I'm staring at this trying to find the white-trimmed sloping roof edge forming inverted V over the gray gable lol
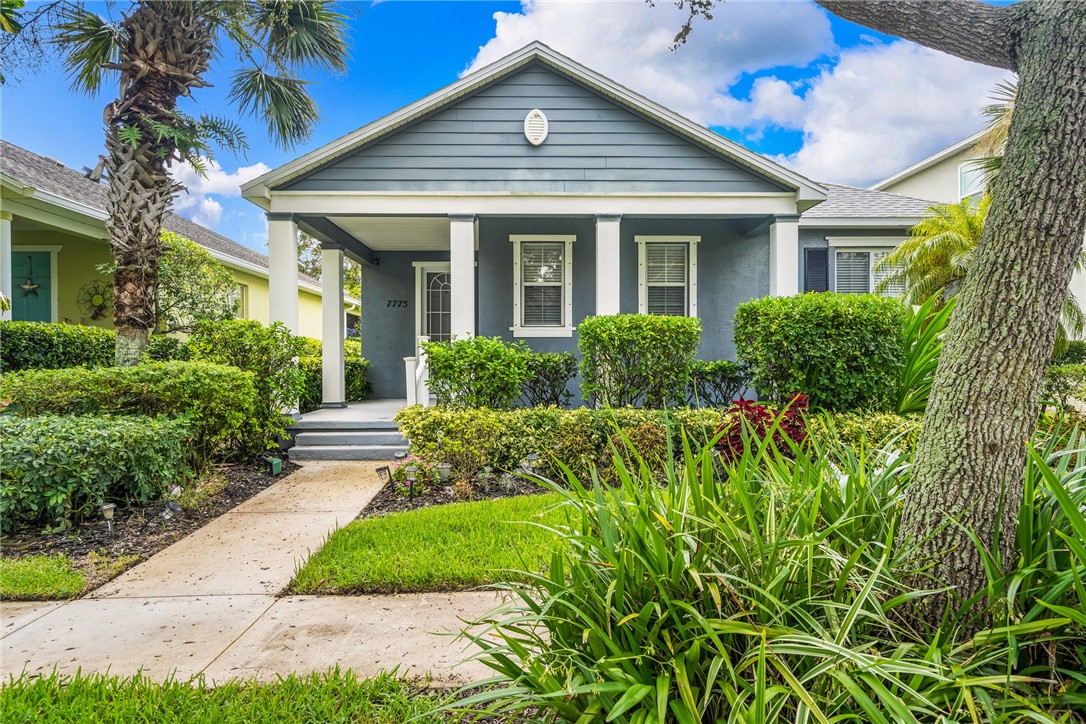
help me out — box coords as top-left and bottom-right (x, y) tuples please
(241, 41), (825, 207)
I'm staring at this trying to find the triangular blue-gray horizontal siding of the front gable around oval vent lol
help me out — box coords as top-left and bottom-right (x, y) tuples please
(283, 64), (783, 193)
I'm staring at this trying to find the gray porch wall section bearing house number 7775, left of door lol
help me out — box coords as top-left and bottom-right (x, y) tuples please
(362, 247), (449, 399)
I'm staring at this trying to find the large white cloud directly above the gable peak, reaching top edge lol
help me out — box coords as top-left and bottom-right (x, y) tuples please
(468, 0), (834, 126)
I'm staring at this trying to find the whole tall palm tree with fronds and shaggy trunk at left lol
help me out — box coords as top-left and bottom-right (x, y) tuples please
(4, 0), (346, 365)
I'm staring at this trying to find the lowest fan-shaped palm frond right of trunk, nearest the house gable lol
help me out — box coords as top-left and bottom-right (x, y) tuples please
(229, 67), (319, 148)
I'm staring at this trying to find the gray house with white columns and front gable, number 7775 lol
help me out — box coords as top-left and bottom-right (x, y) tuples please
(242, 43), (930, 407)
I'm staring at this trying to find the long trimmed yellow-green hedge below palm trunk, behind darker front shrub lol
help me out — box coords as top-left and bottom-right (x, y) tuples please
(0, 361), (256, 463)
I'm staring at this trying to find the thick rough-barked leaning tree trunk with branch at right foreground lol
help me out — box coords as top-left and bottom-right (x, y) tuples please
(819, 0), (1086, 621)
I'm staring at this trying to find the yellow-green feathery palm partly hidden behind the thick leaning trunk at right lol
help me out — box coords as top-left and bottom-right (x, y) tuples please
(875, 195), (1086, 356)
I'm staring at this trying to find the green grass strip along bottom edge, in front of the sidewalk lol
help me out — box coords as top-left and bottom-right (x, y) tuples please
(0, 671), (462, 724)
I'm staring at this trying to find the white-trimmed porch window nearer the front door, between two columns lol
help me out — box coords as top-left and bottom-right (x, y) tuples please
(509, 234), (576, 336)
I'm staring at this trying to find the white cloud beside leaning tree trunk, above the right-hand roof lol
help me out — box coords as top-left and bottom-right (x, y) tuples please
(785, 41), (1007, 186)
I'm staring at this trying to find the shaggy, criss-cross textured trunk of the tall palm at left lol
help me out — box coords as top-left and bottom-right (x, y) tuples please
(105, 0), (214, 365)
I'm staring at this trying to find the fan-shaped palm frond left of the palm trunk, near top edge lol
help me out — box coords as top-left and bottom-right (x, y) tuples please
(52, 5), (125, 93)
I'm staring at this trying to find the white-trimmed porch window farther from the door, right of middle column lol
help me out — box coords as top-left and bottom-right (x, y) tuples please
(634, 237), (700, 317)
